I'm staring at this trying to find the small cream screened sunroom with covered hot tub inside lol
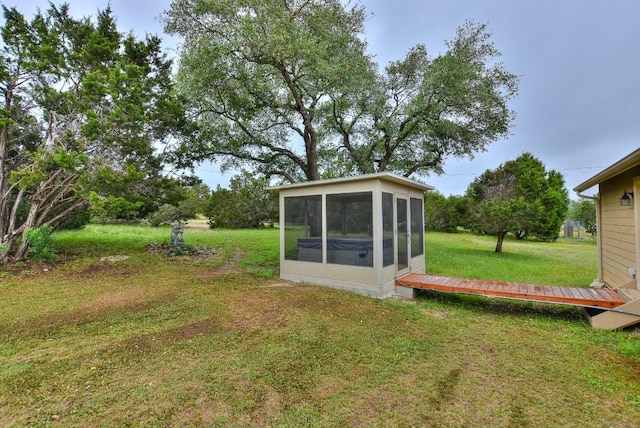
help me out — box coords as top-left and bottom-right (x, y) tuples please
(273, 173), (433, 298)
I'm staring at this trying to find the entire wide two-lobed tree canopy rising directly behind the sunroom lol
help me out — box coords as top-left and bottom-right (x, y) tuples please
(165, 0), (518, 182)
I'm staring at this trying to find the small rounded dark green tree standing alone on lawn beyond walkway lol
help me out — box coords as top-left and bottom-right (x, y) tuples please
(466, 153), (569, 253)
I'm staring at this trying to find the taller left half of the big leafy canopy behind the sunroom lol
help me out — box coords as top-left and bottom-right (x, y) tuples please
(166, 0), (374, 180)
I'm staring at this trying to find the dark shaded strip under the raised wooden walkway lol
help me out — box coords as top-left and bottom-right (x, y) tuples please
(416, 290), (587, 323)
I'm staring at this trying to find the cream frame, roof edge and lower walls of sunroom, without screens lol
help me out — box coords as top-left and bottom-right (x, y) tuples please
(274, 173), (433, 298)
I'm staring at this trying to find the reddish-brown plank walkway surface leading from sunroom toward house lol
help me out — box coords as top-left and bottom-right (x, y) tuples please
(396, 273), (629, 309)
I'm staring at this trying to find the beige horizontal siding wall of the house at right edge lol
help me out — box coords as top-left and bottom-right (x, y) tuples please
(600, 167), (640, 287)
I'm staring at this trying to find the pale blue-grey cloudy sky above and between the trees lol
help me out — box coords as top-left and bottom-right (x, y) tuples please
(6, 0), (640, 198)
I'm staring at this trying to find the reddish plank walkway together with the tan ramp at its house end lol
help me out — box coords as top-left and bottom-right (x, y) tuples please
(396, 273), (640, 329)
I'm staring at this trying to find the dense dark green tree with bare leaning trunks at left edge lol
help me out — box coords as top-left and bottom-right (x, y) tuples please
(0, 4), (184, 262)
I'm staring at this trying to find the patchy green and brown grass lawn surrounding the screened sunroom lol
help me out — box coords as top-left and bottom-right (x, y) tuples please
(0, 226), (640, 427)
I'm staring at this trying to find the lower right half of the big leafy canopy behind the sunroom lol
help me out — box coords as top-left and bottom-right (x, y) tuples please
(369, 22), (518, 175)
